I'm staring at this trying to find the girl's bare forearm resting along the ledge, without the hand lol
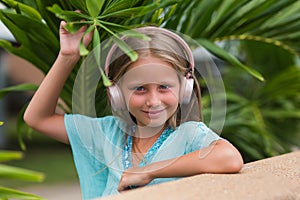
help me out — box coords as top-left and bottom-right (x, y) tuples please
(144, 140), (243, 179)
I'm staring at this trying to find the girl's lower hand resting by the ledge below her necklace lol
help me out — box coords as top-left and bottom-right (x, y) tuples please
(118, 167), (153, 192)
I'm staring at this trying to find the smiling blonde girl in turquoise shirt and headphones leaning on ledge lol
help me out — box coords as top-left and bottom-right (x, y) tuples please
(24, 22), (243, 199)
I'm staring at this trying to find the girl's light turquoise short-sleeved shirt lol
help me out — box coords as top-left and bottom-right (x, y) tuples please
(65, 114), (220, 199)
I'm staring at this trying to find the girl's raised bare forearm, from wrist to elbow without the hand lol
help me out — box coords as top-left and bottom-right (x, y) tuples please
(24, 54), (78, 141)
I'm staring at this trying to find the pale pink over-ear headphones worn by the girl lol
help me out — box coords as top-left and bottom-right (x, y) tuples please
(105, 26), (194, 111)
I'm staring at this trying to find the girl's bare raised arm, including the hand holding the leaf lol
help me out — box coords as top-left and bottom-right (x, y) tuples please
(24, 22), (92, 143)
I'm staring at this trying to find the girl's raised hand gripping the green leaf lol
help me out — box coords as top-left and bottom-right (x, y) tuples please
(59, 21), (93, 58)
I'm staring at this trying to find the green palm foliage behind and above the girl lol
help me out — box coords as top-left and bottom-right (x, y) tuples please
(0, 0), (300, 160)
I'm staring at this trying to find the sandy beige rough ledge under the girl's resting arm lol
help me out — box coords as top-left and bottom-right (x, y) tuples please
(103, 151), (300, 200)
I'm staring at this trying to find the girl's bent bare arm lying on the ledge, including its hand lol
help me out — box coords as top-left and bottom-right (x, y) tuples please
(118, 140), (243, 191)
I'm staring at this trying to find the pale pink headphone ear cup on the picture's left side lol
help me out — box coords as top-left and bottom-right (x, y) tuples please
(108, 85), (126, 111)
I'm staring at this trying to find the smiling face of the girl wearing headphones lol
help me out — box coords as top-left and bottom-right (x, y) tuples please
(120, 56), (180, 127)
